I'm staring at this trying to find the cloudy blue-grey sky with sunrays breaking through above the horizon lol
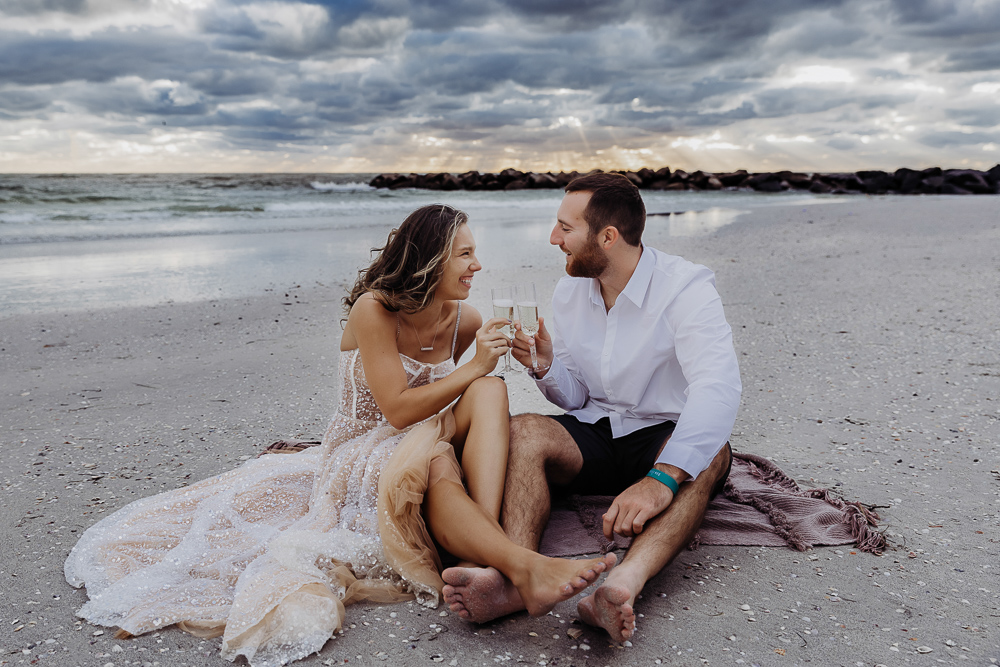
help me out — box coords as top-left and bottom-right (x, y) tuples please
(0, 0), (1000, 173)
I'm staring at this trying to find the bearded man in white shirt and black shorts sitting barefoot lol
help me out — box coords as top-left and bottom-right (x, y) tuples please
(443, 173), (742, 642)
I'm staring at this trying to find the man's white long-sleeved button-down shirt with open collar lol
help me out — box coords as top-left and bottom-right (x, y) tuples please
(537, 248), (743, 478)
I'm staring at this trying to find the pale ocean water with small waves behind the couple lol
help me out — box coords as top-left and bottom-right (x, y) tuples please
(0, 174), (827, 317)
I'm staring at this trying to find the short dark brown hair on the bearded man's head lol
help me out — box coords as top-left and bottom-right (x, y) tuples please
(566, 172), (646, 246)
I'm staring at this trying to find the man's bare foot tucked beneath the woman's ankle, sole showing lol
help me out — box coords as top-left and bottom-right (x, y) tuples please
(441, 567), (524, 623)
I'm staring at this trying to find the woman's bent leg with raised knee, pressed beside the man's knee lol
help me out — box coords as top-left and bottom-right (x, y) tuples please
(452, 377), (510, 520)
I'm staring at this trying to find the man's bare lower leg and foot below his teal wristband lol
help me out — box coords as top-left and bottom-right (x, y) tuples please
(577, 446), (731, 642)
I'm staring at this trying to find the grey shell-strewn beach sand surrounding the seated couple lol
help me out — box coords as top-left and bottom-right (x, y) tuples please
(0, 196), (1000, 667)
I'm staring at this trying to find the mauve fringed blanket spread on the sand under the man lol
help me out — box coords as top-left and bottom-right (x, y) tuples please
(539, 452), (885, 557)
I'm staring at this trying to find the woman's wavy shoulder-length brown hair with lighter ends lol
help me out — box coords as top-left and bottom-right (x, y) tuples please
(344, 204), (469, 313)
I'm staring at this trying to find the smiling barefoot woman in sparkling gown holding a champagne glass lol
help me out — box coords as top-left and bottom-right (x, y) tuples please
(65, 205), (614, 667)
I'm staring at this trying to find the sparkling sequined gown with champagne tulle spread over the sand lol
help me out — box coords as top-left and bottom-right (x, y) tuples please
(65, 314), (461, 667)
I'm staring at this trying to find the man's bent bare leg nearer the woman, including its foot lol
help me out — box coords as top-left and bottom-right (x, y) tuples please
(441, 414), (583, 623)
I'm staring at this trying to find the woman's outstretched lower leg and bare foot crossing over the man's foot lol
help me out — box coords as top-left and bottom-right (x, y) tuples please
(424, 472), (616, 616)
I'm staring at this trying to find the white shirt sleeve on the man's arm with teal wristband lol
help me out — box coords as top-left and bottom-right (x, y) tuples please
(656, 278), (743, 479)
